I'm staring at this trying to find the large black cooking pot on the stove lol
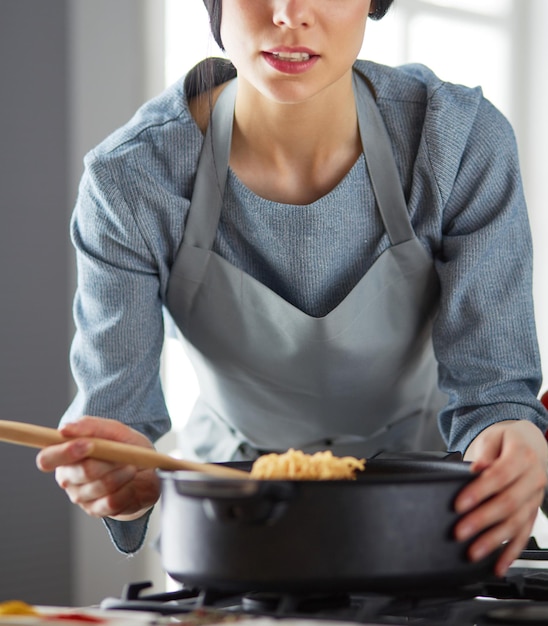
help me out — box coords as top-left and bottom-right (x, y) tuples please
(160, 459), (497, 592)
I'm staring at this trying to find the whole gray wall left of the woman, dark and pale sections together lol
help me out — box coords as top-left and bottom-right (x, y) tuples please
(0, 0), (162, 605)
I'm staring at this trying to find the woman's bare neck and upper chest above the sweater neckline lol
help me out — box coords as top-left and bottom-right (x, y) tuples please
(230, 74), (361, 204)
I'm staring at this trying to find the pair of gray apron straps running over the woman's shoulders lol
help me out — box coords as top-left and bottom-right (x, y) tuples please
(183, 70), (415, 250)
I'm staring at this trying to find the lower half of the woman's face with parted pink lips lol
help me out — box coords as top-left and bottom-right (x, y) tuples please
(221, 0), (371, 103)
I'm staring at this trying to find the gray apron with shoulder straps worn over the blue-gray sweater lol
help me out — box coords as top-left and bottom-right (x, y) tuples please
(167, 68), (445, 461)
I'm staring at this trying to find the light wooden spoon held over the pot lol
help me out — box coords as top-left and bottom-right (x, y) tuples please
(0, 420), (250, 479)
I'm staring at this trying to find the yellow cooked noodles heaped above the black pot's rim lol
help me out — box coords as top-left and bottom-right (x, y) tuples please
(251, 448), (365, 480)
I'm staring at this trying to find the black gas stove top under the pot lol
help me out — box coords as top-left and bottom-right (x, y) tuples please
(101, 540), (548, 626)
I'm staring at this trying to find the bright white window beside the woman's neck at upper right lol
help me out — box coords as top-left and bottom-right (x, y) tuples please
(362, 0), (515, 117)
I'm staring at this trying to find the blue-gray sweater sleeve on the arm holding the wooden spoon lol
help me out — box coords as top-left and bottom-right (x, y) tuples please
(61, 156), (170, 554)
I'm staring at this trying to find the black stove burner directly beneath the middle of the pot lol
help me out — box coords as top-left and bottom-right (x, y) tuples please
(242, 591), (350, 615)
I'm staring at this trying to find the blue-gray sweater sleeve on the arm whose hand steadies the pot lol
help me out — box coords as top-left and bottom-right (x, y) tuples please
(431, 90), (548, 451)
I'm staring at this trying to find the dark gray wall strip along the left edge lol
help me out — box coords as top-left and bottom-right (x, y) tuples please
(0, 0), (71, 603)
